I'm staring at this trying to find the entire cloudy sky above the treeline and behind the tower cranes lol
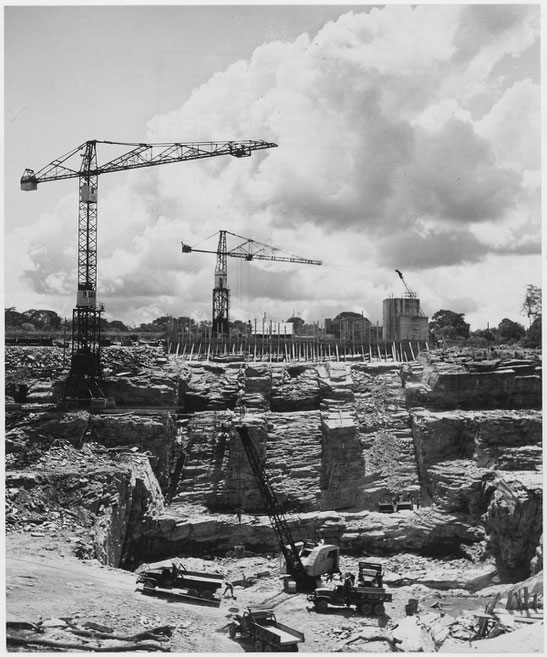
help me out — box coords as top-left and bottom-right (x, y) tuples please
(3, 3), (542, 330)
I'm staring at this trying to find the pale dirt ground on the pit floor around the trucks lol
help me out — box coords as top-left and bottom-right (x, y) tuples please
(6, 532), (540, 653)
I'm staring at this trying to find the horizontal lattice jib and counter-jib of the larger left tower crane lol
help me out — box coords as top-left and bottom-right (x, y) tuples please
(21, 139), (277, 191)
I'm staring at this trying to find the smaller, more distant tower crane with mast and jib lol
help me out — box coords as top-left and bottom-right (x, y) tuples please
(182, 230), (323, 335)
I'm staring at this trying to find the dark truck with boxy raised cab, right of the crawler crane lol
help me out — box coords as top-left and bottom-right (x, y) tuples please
(308, 561), (392, 616)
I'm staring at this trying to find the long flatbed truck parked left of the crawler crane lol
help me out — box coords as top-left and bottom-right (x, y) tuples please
(137, 562), (224, 600)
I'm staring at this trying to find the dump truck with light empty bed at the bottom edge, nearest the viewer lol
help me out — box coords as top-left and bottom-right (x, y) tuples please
(228, 607), (305, 652)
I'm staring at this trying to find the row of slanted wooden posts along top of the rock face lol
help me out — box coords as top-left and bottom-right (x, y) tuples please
(167, 338), (429, 363)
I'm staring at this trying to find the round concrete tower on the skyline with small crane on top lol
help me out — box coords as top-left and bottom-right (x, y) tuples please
(383, 295), (429, 342)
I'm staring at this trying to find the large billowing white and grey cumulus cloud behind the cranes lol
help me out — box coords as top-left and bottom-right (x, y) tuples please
(10, 5), (540, 328)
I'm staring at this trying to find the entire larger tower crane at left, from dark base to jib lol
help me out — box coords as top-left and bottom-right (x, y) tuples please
(21, 139), (277, 398)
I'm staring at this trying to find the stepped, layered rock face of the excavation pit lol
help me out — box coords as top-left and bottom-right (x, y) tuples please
(6, 349), (542, 580)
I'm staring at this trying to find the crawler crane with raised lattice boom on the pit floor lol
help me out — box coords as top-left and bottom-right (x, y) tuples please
(236, 425), (340, 591)
